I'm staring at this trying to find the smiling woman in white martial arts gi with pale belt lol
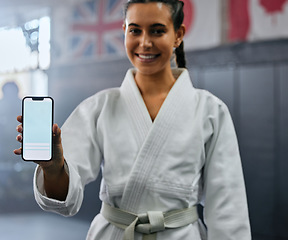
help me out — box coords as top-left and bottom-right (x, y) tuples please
(15, 0), (251, 240)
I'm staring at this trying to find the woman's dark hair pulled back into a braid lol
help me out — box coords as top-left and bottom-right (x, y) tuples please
(124, 0), (186, 68)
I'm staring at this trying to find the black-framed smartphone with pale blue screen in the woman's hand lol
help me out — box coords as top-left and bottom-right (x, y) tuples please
(22, 97), (54, 161)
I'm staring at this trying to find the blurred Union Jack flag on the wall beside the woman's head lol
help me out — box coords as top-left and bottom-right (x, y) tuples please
(69, 0), (125, 59)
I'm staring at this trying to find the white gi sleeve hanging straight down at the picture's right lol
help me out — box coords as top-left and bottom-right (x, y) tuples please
(204, 103), (251, 240)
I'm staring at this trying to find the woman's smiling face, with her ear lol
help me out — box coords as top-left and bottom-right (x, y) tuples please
(123, 2), (183, 75)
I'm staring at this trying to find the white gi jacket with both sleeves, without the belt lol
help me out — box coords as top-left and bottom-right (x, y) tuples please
(34, 69), (251, 240)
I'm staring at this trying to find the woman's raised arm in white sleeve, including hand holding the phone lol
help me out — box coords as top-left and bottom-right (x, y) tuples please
(15, 95), (102, 216)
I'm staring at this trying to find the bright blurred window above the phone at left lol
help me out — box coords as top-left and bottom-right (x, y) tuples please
(0, 17), (50, 100)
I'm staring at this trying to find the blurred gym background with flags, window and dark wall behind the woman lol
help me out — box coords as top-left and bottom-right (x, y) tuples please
(0, 0), (288, 240)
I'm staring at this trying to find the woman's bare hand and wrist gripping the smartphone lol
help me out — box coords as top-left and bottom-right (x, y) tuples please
(14, 116), (69, 201)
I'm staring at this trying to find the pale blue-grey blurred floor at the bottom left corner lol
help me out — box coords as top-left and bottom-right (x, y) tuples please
(0, 212), (90, 240)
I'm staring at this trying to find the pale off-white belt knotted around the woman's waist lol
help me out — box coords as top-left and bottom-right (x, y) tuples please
(101, 203), (198, 240)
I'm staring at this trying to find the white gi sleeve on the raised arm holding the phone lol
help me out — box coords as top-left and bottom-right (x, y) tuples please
(33, 96), (102, 216)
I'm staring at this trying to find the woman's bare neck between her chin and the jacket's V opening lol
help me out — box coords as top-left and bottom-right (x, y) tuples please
(135, 68), (175, 96)
